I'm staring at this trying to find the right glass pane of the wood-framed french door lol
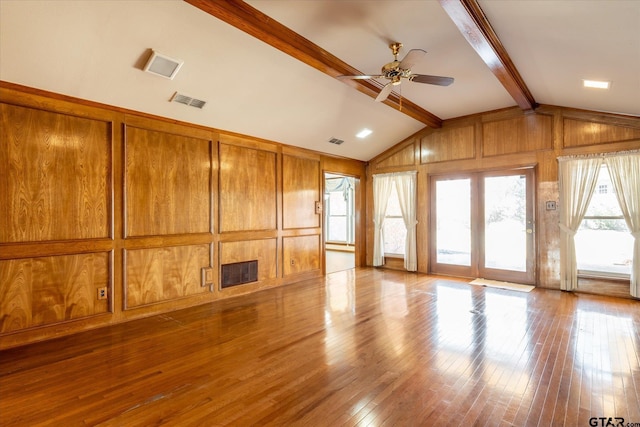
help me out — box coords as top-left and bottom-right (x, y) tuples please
(484, 175), (527, 271)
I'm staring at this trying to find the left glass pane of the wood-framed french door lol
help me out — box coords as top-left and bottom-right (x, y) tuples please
(435, 178), (471, 267)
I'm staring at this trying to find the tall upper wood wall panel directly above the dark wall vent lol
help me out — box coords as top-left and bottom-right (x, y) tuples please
(218, 144), (276, 233)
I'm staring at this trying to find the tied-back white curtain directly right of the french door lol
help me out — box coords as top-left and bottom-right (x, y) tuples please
(558, 157), (602, 291)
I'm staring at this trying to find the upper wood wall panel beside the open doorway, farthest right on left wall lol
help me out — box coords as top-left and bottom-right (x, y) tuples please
(282, 155), (322, 229)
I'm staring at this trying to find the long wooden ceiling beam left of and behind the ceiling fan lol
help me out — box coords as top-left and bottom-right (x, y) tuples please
(185, 0), (442, 128)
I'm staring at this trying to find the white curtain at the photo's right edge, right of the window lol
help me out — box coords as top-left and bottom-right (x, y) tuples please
(605, 152), (640, 298)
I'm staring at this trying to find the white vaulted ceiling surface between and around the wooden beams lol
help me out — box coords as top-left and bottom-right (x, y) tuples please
(0, 0), (640, 160)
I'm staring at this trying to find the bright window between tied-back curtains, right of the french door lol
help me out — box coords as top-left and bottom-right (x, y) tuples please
(575, 165), (633, 278)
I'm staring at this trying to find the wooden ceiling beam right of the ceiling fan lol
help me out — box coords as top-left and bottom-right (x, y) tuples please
(439, 0), (538, 110)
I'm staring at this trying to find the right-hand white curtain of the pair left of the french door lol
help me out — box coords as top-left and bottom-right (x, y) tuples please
(395, 171), (418, 271)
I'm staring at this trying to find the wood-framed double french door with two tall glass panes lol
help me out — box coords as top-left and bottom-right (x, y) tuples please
(430, 168), (535, 283)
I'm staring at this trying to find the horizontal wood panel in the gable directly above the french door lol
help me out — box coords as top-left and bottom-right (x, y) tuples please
(482, 114), (553, 157)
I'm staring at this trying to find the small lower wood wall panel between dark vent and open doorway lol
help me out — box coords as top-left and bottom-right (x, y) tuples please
(282, 235), (322, 276)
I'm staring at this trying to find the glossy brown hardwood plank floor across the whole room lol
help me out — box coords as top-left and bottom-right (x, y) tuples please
(0, 268), (640, 427)
